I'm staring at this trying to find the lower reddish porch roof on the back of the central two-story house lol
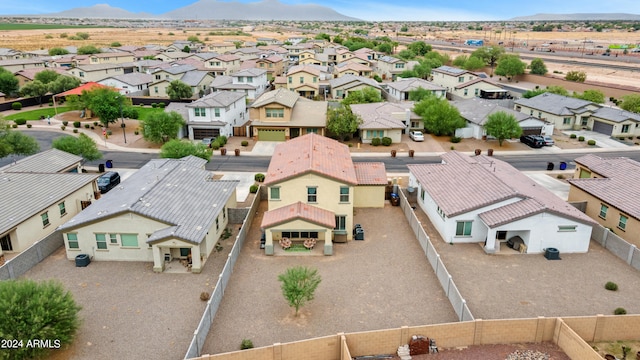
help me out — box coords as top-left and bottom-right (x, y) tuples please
(260, 201), (336, 229)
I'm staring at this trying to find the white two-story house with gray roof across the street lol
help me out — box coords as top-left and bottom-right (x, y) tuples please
(186, 91), (248, 140)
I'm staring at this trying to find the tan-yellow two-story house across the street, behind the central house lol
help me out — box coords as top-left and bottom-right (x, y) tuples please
(249, 89), (328, 141)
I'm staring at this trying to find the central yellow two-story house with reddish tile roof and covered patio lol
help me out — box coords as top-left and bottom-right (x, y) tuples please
(260, 134), (387, 255)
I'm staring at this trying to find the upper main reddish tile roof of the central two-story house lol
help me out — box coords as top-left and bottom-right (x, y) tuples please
(265, 133), (358, 185)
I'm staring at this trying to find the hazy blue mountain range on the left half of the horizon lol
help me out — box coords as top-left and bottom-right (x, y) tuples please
(34, 0), (359, 21)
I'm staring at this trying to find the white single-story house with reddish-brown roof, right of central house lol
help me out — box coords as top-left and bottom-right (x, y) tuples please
(408, 151), (596, 254)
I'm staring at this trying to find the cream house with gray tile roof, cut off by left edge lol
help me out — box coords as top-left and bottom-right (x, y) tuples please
(0, 149), (100, 258)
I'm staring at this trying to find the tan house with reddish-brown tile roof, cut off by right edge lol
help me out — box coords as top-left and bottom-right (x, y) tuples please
(568, 154), (640, 246)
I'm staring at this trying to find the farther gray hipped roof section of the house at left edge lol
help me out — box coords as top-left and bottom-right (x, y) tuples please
(0, 149), (82, 173)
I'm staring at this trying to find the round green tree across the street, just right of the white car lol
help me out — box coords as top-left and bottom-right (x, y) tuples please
(413, 95), (466, 136)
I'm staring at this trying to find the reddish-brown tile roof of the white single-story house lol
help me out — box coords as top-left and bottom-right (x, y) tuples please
(408, 151), (595, 226)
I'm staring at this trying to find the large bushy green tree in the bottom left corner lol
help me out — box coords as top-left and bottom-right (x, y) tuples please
(0, 280), (81, 359)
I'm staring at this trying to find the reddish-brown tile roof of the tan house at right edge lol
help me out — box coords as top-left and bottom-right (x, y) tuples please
(568, 154), (640, 220)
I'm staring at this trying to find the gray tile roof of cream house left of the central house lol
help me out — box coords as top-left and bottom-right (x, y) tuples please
(59, 157), (238, 244)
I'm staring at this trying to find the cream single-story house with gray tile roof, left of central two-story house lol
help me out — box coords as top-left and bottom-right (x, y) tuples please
(58, 157), (238, 273)
